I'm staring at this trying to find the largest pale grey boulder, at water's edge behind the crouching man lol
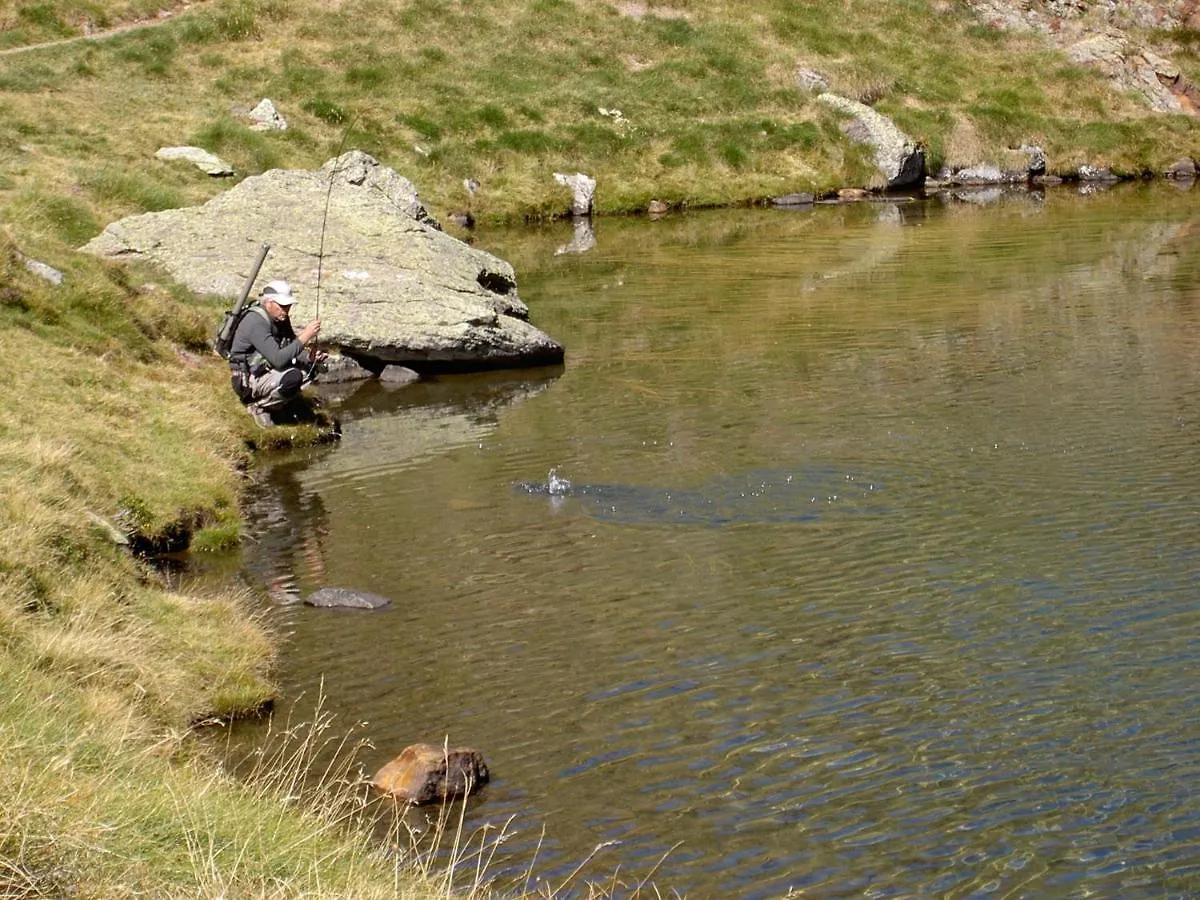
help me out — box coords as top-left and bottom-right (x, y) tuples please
(84, 151), (563, 371)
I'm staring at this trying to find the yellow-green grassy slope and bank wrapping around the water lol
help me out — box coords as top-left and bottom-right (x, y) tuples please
(0, 0), (1200, 898)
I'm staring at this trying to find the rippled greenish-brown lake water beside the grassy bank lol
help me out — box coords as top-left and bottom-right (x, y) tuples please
(231, 184), (1200, 898)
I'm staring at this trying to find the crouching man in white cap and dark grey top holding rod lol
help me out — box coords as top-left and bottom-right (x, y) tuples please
(229, 281), (320, 427)
